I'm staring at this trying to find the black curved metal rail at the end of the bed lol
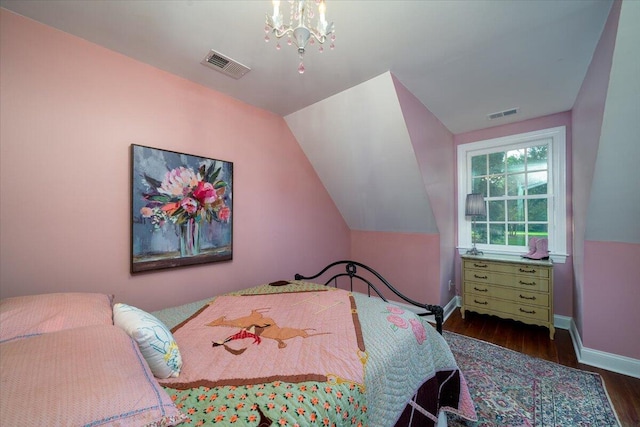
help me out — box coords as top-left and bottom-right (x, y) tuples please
(295, 260), (444, 333)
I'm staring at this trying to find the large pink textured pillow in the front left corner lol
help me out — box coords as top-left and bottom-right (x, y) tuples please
(0, 325), (185, 426)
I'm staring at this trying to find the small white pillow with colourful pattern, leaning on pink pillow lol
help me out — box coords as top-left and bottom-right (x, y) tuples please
(113, 303), (182, 378)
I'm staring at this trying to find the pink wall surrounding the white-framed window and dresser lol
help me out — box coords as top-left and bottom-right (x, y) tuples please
(454, 111), (573, 317)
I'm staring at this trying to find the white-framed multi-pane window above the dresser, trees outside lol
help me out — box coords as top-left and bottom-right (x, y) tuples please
(458, 126), (567, 262)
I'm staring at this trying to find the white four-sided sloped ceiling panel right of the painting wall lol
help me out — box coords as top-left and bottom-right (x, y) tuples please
(285, 72), (438, 233)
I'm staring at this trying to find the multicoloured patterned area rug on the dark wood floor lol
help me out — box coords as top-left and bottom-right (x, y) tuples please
(443, 331), (620, 427)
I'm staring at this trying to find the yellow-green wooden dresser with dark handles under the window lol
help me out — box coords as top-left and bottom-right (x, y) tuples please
(460, 255), (555, 339)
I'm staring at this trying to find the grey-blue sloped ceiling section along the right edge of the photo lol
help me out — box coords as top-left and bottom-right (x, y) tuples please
(586, 1), (640, 243)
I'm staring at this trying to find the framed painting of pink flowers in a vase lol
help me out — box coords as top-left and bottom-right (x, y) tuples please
(131, 144), (233, 273)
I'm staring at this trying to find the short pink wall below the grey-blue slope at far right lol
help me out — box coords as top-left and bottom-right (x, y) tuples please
(581, 241), (640, 360)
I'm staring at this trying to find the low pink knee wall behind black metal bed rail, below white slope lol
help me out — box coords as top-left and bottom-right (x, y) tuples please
(351, 230), (440, 304)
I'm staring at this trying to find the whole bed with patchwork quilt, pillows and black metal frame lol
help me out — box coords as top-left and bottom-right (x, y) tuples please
(0, 261), (475, 427)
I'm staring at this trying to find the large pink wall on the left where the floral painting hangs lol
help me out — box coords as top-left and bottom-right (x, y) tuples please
(0, 10), (350, 310)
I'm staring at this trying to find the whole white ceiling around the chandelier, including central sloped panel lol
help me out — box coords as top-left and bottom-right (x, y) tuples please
(0, 0), (611, 233)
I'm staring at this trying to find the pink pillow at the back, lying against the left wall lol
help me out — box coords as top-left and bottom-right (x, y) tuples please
(0, 292), (113, 343)
